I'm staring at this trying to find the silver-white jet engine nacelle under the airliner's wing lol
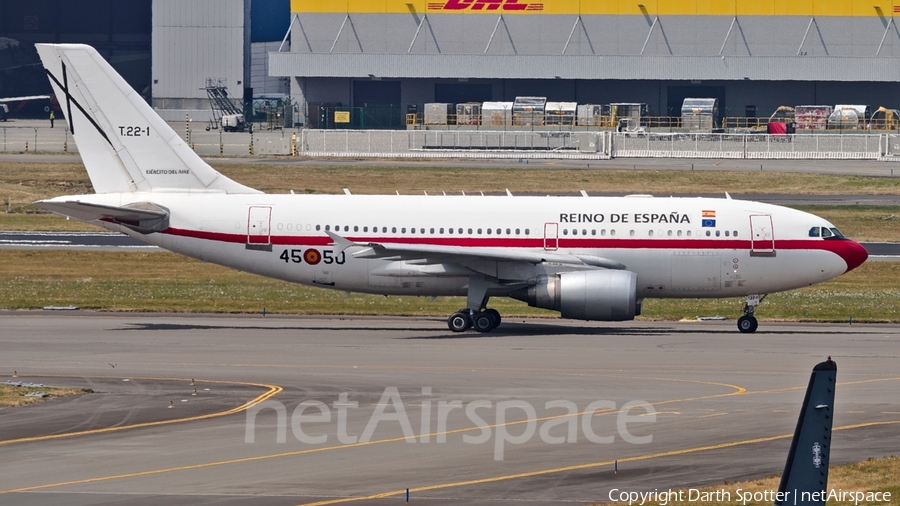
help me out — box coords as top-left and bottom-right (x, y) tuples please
(512, 270), (638, 322)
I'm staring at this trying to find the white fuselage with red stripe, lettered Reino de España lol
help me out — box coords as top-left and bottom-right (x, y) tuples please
(67, 192), (858, 299)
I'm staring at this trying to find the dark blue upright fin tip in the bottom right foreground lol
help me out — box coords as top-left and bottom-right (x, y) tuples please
(775, 357), (837, 506)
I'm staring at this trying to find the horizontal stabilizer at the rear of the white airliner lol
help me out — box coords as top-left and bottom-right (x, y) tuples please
(34, 199), (169, 234)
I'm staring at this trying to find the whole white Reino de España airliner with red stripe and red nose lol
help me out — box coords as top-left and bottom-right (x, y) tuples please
(37, 44), (868, 332)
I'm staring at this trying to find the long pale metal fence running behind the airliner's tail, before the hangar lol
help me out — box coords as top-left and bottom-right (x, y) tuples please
(7, 122), (900, 161)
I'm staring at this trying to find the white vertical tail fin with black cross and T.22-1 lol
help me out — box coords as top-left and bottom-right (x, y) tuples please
(37, 44), (260, 193)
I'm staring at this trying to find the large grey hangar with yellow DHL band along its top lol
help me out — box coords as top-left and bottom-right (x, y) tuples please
(269, 0), (900, 127)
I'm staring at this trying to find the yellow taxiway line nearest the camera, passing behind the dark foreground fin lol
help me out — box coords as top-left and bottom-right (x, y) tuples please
(300, 420), (900, 506)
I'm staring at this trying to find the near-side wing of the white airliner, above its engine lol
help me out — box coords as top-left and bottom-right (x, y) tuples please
(327, 232), (625, 269)
